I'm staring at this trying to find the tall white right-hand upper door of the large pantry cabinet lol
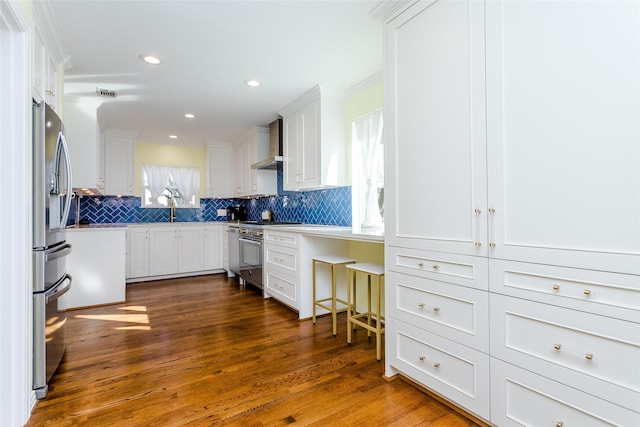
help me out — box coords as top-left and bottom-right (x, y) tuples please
(486, 1), (640, 274)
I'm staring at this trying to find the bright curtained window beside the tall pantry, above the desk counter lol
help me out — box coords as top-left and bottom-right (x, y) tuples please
(351, 109), (384, 229)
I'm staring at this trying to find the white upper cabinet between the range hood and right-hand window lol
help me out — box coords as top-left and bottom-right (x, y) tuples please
(280, 86), (348, 190)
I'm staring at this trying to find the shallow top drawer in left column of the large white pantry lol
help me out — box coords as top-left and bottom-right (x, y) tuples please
(385, 246), (489, 290)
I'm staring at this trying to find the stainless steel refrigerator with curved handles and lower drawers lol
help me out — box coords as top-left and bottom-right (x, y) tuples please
(33, 102), (73, 399)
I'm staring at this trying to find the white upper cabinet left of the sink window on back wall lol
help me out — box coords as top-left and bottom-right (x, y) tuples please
(103, 133), (134, 196)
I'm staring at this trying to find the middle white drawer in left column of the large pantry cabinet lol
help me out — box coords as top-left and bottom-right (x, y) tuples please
(385, 272), (489, 353)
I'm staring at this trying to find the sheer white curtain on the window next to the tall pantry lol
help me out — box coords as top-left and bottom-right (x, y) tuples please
(353, 110), (384, 228)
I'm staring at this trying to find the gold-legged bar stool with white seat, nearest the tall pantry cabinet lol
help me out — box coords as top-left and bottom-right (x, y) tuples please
(347, 262), (384, 360)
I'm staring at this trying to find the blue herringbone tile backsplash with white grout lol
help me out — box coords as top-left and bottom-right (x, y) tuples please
(69, 167), (351, 226)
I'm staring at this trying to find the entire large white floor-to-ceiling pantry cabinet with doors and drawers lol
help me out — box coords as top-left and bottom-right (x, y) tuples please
(374, 0), (640, 425)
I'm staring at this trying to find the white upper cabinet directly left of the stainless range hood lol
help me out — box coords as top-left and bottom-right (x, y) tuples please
(233, 127), (278, 197)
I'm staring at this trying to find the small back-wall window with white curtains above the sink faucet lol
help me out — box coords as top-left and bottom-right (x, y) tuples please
(142, 165), (200, 208)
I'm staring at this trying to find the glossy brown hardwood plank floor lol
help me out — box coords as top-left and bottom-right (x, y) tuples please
(27, 275), (476, 427)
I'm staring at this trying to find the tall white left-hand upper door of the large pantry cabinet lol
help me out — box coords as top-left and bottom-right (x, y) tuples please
(385, 1), (487, 255)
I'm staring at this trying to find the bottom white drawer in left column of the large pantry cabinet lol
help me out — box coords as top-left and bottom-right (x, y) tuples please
(386, 319), (489, 419)
